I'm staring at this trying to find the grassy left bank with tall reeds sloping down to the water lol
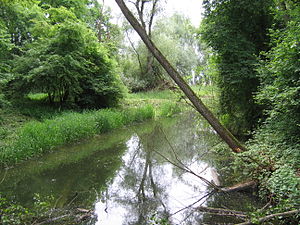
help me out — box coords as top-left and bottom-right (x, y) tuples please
(0, 90), (202, 166)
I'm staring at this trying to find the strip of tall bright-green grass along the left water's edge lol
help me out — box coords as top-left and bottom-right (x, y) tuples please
(0, 105), (155, 164)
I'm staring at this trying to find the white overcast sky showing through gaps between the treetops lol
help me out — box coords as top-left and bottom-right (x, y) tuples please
(103, 0), (203, 27)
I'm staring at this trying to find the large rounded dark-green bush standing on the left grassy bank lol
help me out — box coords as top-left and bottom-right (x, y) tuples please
(6, 21), (125, 109)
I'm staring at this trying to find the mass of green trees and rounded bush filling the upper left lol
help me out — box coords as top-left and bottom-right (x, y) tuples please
(0, 1), (123, 108)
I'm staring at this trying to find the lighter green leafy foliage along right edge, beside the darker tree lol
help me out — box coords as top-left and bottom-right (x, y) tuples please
(252, 1), (300, 210)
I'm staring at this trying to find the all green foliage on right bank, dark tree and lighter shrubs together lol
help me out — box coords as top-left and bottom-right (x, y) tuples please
(201, 0), (300, 219)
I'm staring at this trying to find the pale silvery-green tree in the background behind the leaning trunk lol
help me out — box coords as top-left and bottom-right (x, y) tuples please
(119, 11), (200, 92)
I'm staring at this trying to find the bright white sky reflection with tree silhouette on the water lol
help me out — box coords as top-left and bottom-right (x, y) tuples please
(95, 129), (218, 225)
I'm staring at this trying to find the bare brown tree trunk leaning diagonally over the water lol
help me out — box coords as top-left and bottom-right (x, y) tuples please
(115, 0), (245, 152)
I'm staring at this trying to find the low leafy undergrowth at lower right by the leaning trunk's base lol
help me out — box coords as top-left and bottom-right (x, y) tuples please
(215, 124), (300, 224)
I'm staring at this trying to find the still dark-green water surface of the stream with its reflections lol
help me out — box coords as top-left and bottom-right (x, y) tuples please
(0, 114), (259, 225)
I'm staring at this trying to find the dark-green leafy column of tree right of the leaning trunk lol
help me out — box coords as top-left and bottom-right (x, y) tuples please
(201, 0), (272, 136)
